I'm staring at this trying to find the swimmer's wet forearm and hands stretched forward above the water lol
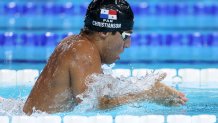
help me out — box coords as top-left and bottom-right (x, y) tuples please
(99, 82), (187, 109)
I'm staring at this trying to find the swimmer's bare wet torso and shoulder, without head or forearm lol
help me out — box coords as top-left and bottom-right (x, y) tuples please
(24, 36), (101, 114)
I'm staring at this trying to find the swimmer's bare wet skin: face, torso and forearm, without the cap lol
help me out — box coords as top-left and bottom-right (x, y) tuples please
(23, 32), (187, 115)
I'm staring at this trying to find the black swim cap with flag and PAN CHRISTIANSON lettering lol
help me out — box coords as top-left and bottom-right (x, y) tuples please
(84, 0), (134, 32)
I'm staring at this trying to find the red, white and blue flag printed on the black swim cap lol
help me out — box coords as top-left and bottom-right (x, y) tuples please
(100, 9), (117, 20)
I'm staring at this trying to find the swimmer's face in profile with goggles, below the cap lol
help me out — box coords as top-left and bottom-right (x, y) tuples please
(102, 31), (132, 64)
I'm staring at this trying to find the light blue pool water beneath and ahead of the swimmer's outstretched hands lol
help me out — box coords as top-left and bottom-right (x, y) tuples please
(61, 89), (218, 116)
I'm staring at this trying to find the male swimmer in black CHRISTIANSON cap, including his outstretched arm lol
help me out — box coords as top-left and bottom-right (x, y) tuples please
(23, 0), (187, 115)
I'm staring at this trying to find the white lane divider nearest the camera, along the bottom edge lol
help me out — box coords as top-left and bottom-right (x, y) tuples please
(0, 114), (216, 123)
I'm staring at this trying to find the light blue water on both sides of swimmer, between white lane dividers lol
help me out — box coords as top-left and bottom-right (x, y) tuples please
(0, 86), (218, 116)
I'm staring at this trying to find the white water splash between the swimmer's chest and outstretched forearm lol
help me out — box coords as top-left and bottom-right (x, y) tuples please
(75, 67), (164, 111)
